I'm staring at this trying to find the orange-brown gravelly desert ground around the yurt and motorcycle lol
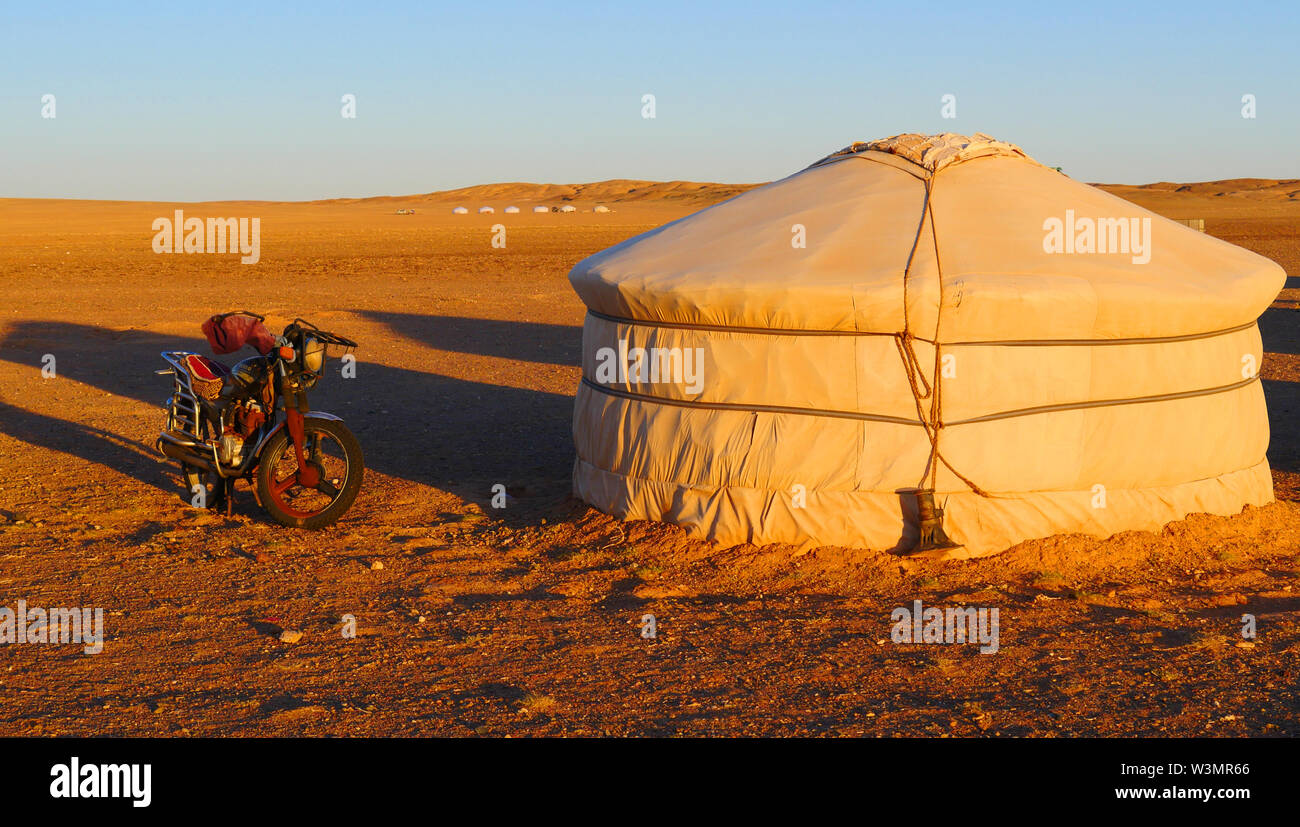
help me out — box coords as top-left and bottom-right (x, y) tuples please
(0, 179), (1300, 736)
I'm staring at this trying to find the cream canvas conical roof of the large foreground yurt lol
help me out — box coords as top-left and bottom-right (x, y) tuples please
(569, 134), (1284, 342)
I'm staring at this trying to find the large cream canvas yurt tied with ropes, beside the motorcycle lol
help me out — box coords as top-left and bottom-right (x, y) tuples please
(569, 134), (1284, 558)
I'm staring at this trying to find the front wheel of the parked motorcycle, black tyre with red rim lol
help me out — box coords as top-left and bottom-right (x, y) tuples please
(257, 419), (365, 529)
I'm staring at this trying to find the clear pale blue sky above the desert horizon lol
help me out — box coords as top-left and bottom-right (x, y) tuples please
(0, 0), (1300, 200)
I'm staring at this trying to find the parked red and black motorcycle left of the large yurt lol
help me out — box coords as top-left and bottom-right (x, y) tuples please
(155, 311), (365, 529)
